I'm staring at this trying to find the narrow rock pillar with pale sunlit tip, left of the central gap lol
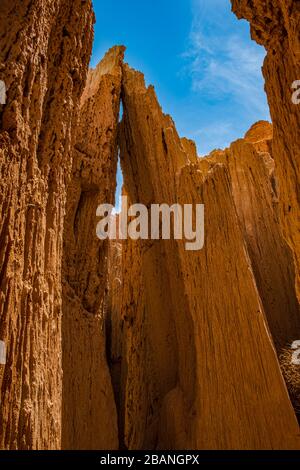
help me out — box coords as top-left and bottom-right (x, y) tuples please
(62, 47), (124, 449)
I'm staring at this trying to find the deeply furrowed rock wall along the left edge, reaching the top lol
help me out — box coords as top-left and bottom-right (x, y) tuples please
(0, 0), (94, 449)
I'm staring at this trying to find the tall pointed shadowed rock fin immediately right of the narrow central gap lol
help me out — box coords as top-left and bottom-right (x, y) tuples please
(120, 66), (195, 449)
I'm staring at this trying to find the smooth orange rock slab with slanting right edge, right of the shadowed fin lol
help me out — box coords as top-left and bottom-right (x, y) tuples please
(176, 165), (299, 449)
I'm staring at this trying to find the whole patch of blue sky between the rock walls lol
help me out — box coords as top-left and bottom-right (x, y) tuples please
(91, 0), (269, 207)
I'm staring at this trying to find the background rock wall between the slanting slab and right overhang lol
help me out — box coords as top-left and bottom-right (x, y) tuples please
(199, 121), (300, 418)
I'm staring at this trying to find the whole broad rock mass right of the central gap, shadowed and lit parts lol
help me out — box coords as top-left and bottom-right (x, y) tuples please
(120, 66), (299, 449)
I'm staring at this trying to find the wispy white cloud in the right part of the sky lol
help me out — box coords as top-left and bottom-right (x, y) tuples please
(184, 0), (268, 116)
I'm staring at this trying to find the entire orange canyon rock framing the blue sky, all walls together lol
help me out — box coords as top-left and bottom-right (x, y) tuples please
(0, 0), (300, 449)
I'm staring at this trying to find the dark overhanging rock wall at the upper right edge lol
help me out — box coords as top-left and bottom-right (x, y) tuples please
(232, 0), (300, 298)
